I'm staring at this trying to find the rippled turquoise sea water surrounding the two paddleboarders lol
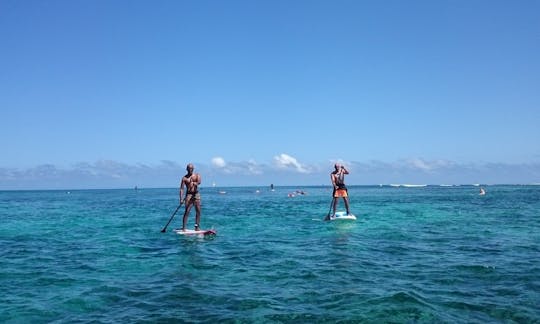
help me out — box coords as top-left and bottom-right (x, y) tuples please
(0, 186), (540, 323)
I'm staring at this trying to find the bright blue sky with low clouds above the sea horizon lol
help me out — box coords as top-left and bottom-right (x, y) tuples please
(0, 0), (540, 190)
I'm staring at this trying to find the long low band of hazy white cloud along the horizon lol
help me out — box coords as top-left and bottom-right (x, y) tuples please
(0, 157), (540, 190)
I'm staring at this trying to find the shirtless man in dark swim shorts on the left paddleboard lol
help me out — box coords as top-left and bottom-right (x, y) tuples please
(180, 163), (202, 231)
